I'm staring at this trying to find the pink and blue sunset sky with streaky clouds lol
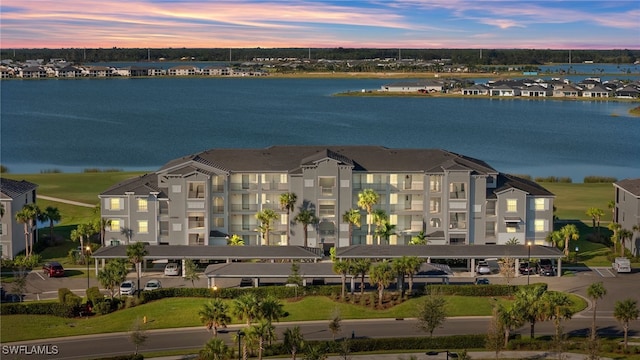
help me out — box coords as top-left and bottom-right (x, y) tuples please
(0, 0), (640, 49)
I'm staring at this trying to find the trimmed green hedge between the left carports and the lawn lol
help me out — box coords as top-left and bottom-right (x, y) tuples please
(140, 285), (340, 303)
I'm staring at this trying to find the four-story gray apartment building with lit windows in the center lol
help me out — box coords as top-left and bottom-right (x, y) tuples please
(99, 146), (554, 248)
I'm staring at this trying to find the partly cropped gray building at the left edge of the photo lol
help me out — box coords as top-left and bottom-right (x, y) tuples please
(0, 178), (38, 259)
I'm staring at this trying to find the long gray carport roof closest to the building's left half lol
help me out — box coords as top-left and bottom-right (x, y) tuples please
(93, 245), (322, 260)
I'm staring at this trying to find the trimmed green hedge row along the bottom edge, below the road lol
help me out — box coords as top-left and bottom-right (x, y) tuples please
(265, 335), (486, 356)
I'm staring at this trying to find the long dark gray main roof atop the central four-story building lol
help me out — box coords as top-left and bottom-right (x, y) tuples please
(160, 145), (497, 174)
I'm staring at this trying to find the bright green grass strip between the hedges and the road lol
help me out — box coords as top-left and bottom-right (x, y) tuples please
(0, 294), (586, 343)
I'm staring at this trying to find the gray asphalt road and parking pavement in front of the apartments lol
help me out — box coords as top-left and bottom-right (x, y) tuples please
(3, 271), (640, 359)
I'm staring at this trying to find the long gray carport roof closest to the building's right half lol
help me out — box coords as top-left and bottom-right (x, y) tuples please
(336, 245), (564, 259)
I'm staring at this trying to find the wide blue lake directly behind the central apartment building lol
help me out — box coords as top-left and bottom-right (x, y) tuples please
(0, 78), (640, 182)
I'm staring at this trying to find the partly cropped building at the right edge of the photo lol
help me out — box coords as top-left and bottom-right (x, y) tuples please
(613, 179), (640, 256)
